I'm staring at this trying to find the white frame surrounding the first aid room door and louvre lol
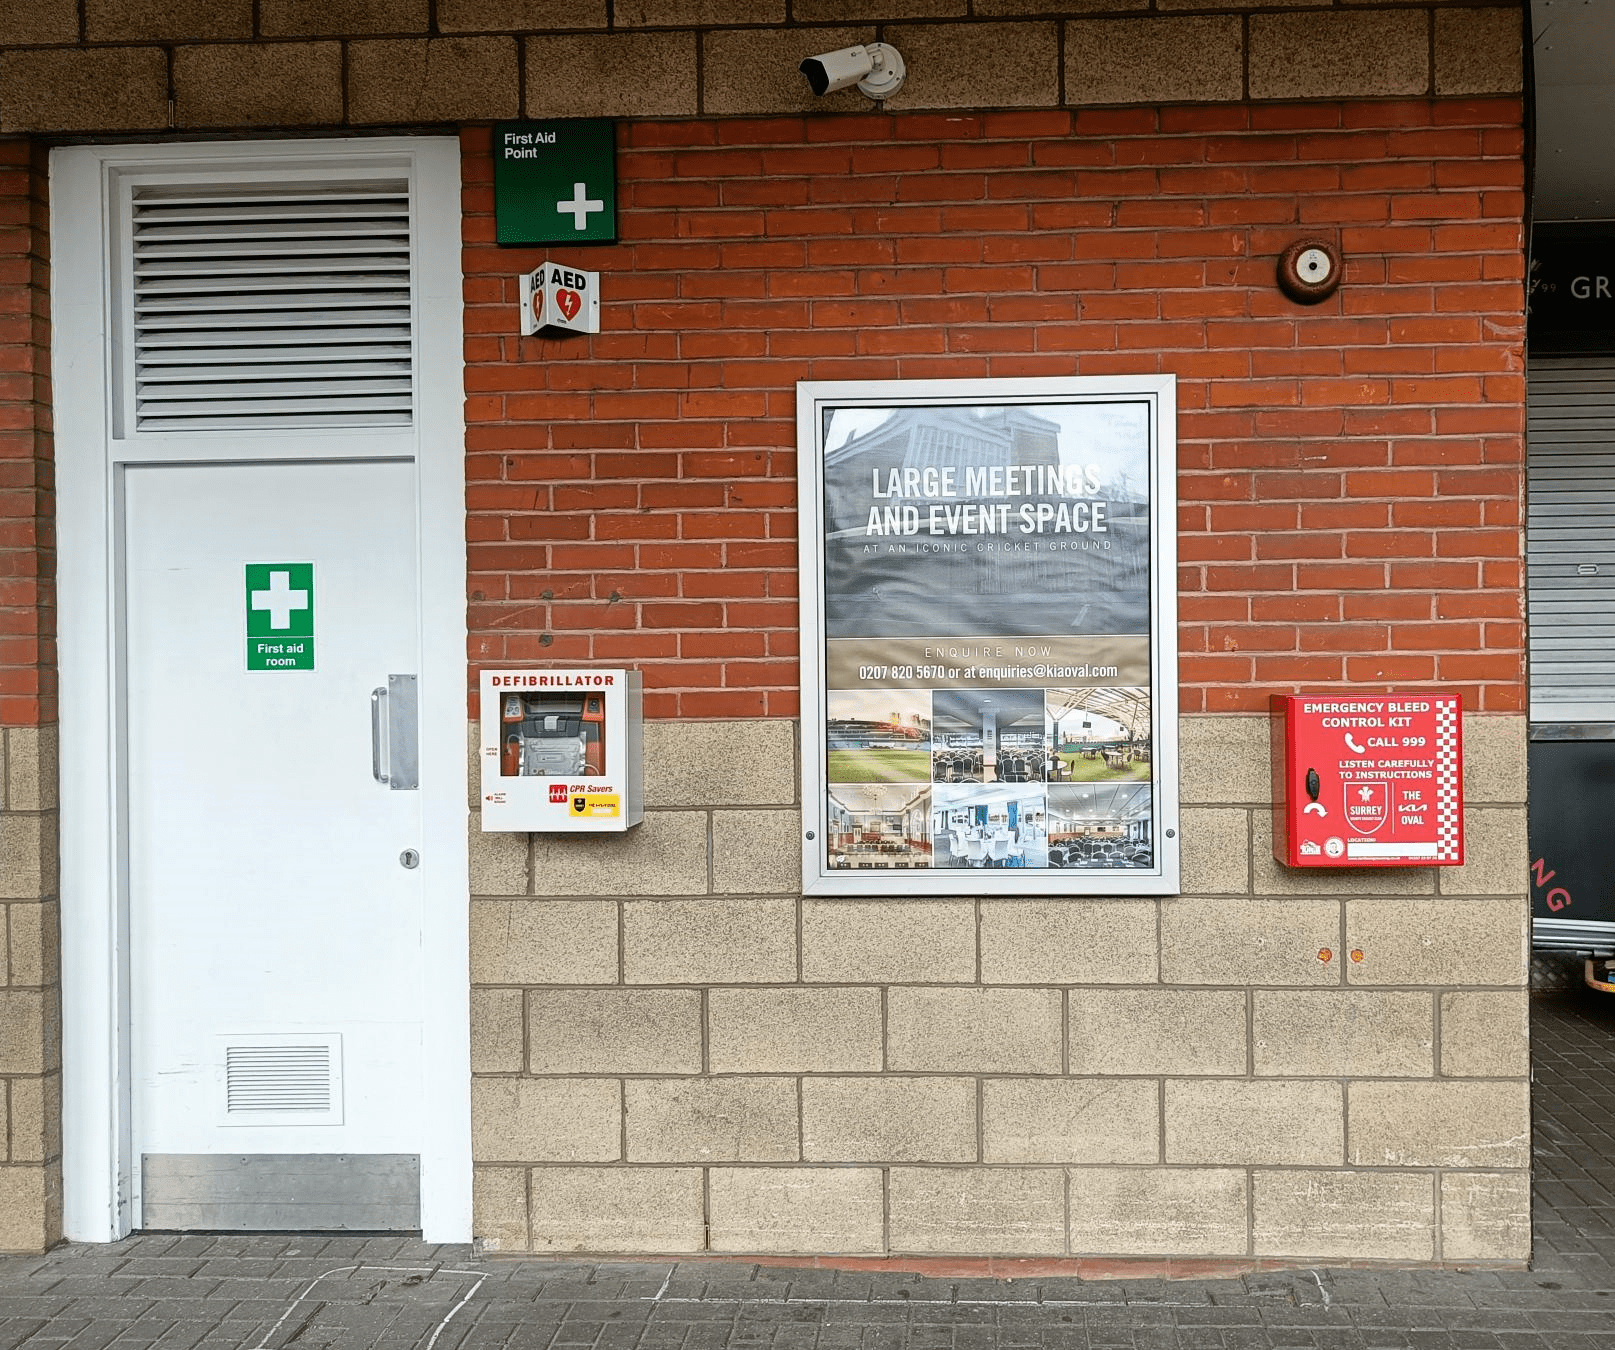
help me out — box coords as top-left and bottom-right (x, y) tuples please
(50, 137), (472, 1242)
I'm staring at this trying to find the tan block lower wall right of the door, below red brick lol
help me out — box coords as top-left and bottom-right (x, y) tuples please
(472, 715), (1529, 1263)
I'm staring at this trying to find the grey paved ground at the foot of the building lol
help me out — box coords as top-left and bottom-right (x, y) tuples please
(0, 992), (1615, 1350)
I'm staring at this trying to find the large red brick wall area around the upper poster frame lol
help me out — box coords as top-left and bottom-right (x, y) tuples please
(464, 99), (1525, 717)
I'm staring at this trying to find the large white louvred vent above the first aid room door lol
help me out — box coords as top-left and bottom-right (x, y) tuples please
(128, 179), (413, 433)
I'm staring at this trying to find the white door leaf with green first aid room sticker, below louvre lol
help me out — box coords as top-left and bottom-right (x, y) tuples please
(123, 462), (422, 1229)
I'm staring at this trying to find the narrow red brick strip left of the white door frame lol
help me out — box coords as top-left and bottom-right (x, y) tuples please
(0, 139), (57, 727)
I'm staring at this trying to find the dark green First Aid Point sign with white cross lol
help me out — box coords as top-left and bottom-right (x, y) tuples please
(494, 119), (617, 244)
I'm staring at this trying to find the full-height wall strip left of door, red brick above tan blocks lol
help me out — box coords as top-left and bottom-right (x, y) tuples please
(0, 139), (61, 1251)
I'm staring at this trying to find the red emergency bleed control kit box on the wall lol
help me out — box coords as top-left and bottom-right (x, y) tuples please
(1273, 693), (1463, 867)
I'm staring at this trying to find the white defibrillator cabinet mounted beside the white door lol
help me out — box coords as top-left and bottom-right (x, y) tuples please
(481, 669), (644, 833)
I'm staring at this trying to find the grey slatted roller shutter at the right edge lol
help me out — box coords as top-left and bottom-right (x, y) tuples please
(1526, 355), (1615, 722)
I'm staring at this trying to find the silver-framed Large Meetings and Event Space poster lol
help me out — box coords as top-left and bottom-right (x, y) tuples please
(796, 375), (1182, 896)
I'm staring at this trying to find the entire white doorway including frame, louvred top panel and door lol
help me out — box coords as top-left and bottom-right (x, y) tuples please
(50, 137), (472, 1242)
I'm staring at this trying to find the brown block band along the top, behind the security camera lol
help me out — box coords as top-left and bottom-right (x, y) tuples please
(0, 0), (1523, 132)
